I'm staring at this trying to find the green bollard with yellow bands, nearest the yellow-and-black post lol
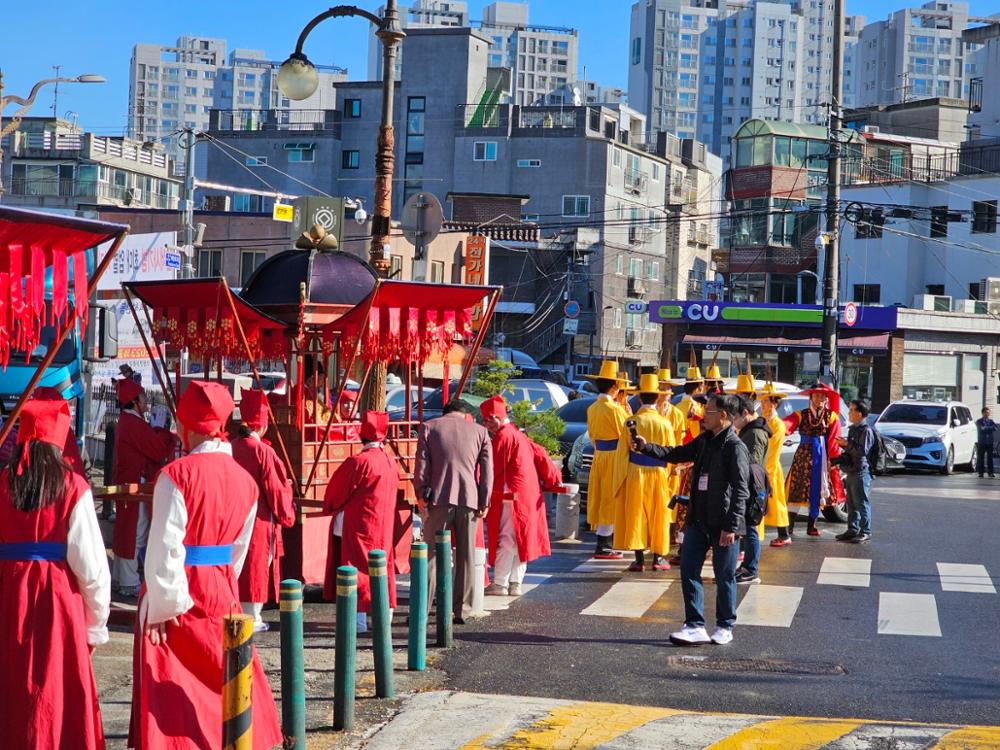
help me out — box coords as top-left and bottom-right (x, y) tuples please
(279, 578), (306, 750)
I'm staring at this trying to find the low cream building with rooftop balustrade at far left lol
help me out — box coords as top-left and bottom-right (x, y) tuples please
(2, 117), (180, 211)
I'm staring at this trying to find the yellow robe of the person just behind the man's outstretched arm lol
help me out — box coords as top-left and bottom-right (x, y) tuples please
(614, 405), (674, 555)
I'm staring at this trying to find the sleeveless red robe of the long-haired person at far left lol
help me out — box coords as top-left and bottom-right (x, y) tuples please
(0, 469), (104, 750)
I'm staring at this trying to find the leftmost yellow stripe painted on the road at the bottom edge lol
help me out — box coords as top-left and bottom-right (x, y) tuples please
(460, 703), (687, 750)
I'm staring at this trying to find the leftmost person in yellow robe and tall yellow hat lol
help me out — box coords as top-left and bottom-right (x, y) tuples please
(586, 360), (628, 560)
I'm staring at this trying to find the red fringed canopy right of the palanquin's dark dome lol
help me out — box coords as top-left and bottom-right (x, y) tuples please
(322, 281), (499, 365)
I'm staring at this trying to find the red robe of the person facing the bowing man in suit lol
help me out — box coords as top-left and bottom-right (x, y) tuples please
(486, 422), (552, 565)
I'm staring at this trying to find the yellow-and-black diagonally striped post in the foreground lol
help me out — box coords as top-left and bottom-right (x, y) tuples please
(222, 615), (253, 750)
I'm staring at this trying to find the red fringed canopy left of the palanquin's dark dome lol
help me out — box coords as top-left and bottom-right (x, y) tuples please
(123, 278), (285, 359)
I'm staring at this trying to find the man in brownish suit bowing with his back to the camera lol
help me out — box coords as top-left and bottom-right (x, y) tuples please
(413, 398), (493, 625)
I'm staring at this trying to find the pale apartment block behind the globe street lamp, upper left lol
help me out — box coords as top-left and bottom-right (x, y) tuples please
(128, 36), (347, 168)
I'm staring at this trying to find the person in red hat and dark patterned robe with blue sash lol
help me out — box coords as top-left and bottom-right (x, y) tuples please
(785, 382), (844, 536)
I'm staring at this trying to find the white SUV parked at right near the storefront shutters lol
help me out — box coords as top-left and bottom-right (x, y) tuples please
(875, 399), (977, 474)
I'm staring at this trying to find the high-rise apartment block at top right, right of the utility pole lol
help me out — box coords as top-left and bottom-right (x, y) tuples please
(854, 0), (990, 107)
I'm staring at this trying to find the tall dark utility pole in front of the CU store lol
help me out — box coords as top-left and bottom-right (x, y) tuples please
(820, 0), (844, 388)
